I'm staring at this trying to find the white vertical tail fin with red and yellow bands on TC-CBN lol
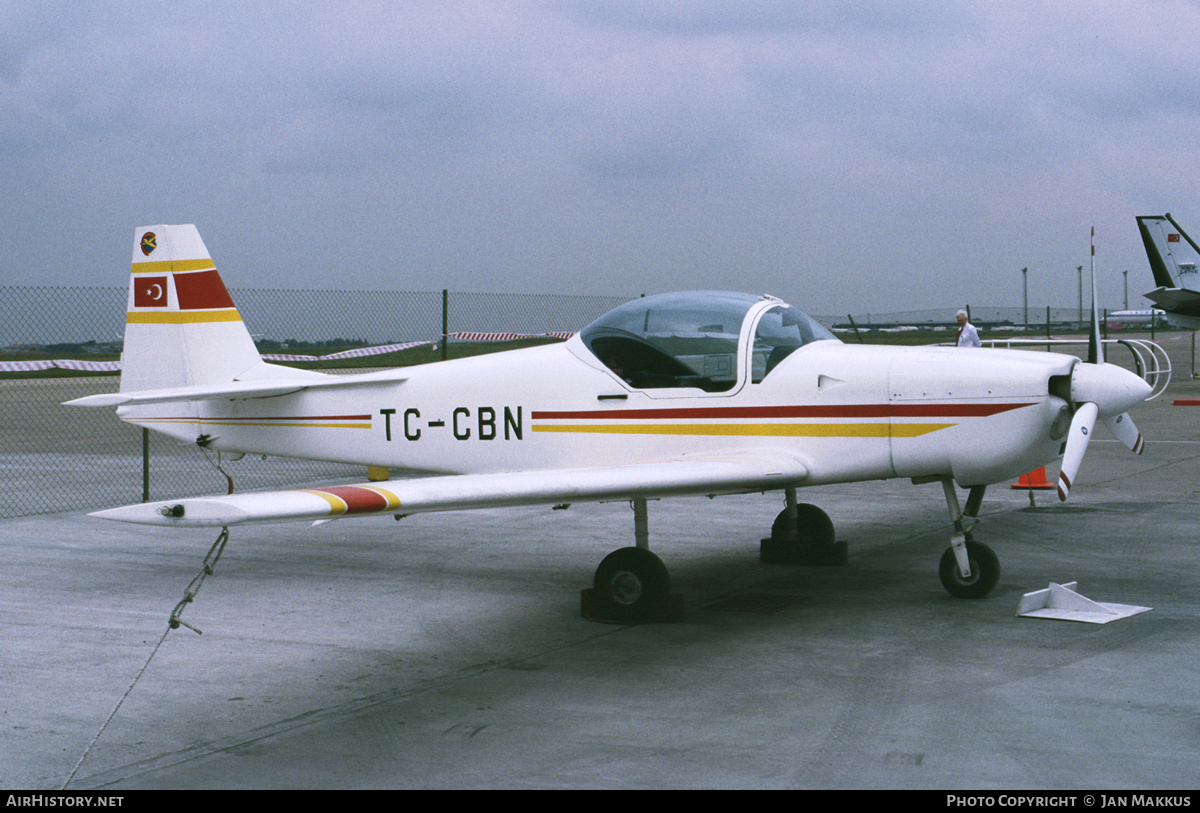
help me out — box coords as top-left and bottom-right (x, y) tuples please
(120, 225), (264, 392)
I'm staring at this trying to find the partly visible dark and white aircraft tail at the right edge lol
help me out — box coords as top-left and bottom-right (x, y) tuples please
(1138, 213), (1200, 330)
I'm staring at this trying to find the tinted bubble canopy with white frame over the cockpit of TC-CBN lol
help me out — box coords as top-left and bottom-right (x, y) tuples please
(580, 291), (838, 392)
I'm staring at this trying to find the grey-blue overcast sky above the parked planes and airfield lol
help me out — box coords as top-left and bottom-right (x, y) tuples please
(0, 0), (1200, 320)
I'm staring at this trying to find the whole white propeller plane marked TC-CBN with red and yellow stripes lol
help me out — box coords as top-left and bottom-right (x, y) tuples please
(70, 225), (1151, 621)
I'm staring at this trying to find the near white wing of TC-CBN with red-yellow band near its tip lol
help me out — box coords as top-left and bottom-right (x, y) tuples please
(91, 452), (809, 528)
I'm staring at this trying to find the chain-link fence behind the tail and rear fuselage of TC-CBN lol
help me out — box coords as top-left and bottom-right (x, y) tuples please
(0, 287), (631, 518)
